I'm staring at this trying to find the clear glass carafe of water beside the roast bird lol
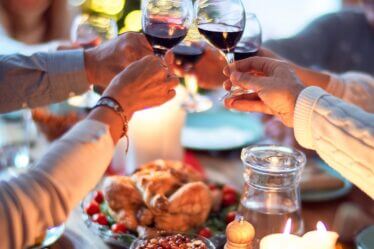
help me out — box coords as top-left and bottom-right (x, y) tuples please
(239, 145), (306, 248)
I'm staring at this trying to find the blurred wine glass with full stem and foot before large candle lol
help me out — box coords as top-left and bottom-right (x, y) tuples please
(172, 41), (213, 113)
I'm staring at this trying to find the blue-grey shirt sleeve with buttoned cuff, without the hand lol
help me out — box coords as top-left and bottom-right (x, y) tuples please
(0, 50), (89, 113)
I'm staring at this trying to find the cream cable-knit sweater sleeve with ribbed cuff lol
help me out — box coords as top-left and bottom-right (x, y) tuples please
(294, 87), (374, 198)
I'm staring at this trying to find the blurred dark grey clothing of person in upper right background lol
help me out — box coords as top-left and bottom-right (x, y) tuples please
(264, 0), (374, 75)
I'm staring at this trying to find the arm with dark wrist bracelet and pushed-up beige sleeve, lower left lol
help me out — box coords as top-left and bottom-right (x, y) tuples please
(0, 56), (178, 248)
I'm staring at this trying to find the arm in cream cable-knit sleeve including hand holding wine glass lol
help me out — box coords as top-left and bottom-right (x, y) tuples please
(225, 58), (374, 198)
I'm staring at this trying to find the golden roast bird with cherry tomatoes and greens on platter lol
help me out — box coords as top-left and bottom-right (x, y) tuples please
(85, 160), (239, 244)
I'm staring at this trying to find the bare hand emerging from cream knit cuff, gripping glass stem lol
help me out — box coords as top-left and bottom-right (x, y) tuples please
(224, 57), (304, 127)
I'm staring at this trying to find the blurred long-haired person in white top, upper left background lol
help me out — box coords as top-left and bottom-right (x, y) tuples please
(0, 0), (77, 55)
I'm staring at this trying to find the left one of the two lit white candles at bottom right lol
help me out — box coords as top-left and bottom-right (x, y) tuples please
(260, 219), (304, 249)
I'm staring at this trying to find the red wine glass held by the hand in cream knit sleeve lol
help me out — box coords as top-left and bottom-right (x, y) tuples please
(195, 0), (245, 63)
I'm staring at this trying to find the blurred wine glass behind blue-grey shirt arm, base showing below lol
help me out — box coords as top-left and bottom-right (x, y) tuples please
(68, 14), (118, 108)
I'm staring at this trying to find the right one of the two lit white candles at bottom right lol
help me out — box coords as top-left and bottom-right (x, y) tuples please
(303, 221), (339, 249)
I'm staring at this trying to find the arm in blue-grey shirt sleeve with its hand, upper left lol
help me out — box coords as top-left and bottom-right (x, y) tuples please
(0, 33), (152, 113)
